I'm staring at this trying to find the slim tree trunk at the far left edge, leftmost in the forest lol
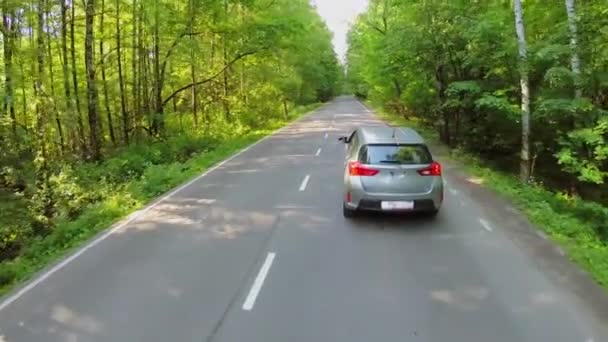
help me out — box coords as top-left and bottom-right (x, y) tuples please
(2, 9), (17, 137)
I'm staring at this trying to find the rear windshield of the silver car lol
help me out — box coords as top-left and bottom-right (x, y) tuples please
(359, 144), (433, 165)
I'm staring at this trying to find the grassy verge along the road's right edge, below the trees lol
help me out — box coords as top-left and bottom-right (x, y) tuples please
(368, 104), (608, 289)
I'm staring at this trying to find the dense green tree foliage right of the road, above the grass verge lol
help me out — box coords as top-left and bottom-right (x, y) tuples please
(347, 0), (608, 187)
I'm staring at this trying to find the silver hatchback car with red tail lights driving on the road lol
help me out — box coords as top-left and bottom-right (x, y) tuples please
(339, 126), (443, 218)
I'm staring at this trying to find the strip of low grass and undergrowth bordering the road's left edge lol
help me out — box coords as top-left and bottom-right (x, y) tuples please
(0, 104), (321, 295)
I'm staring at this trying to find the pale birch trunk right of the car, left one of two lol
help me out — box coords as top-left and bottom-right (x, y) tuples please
(513, 0), (530, 182)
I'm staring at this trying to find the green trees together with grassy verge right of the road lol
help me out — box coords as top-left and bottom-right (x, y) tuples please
(347, 0), (608, 287)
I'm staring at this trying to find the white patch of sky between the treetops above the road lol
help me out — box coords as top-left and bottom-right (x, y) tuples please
(312, 0), (367, 61)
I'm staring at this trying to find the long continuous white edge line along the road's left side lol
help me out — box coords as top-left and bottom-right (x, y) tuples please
(0, 104), (328, 311)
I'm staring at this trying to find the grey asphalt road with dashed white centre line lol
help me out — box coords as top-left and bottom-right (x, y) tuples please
(0, 97), (608, 342)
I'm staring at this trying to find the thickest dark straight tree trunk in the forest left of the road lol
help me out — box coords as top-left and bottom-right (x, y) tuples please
(84, 0), (101, 161)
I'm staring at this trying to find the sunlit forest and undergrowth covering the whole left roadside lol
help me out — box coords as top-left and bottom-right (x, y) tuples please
(0, 0), (343, 293)
